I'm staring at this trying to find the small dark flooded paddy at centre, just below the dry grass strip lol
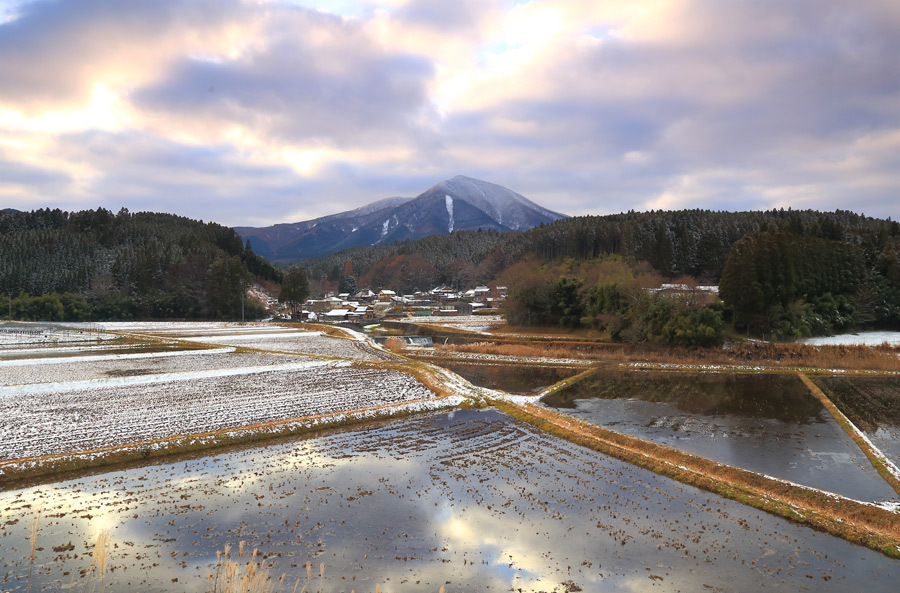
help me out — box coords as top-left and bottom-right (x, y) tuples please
(434, 360), (584, 394)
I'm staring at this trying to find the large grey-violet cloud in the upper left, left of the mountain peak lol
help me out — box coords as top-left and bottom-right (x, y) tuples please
(132, 20), (440, 146)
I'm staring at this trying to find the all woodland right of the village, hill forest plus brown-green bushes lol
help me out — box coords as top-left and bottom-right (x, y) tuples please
(304, 210), (900, 347)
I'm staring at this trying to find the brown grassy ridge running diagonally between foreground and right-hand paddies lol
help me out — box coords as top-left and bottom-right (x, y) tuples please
(491, 401), (900, 558)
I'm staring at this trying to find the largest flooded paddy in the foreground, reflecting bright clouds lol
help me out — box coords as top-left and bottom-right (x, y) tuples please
(0, 410), (900, 593)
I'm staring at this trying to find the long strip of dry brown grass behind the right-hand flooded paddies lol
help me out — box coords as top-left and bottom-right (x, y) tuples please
(434, 342), (900, 371)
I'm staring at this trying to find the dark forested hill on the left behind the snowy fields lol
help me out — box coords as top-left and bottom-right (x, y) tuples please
(0, 208), (281, 319)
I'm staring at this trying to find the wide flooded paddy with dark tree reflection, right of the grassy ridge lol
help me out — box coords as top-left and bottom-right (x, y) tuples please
(544, 370), (897, 501)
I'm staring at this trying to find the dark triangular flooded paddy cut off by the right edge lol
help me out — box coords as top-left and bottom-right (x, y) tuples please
(815, 376), (900, 465)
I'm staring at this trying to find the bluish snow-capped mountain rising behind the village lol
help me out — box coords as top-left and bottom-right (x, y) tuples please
(235, 175), (567, 263)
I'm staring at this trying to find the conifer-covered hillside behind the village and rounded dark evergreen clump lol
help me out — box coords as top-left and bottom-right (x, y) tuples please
(302, 210), (900, 284)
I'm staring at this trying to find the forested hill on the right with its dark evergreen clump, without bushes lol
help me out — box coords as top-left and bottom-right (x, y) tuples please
(303, 210), (900, 335)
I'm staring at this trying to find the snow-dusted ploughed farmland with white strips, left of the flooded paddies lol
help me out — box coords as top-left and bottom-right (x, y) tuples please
(0, 323), (435, 469)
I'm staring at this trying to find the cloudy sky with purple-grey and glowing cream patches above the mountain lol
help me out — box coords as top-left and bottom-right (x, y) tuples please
(0, 0), (900, 226)
